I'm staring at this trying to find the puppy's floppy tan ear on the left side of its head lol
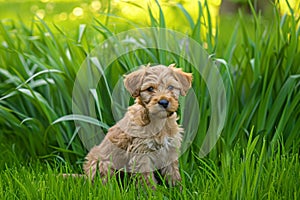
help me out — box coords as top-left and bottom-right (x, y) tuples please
(124, 67), (146, 97)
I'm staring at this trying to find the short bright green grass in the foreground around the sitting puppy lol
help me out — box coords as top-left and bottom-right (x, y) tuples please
(0, 141), (300, 199)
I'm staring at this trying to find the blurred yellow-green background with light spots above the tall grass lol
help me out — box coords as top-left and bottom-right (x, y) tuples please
(0, 0), (300, 53)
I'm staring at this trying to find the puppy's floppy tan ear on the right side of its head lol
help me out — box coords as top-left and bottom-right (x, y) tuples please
(169, 64), (193, 96)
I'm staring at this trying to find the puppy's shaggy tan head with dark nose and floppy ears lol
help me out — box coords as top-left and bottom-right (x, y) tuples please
(124, 64), (192, 118)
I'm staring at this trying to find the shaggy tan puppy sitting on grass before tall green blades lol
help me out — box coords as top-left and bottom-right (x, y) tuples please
(84, 64), (192, 188)
